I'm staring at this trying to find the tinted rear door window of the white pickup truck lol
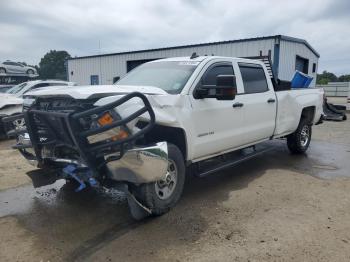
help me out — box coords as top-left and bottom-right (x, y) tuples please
(238, 63), (269, 94)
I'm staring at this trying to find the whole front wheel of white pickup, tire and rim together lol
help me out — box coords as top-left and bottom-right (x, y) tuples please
(132, 144), (186, 215)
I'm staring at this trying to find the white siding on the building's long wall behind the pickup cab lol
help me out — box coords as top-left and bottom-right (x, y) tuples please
(68, 39), (274, 85)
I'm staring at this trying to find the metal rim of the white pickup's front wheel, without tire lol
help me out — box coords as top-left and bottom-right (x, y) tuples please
(155, 159), (178, 200)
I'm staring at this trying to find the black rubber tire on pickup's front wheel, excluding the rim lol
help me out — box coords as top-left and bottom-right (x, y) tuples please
(131, 144), (186, 216)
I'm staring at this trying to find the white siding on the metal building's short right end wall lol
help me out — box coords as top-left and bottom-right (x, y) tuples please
(278, 40), (318, 86)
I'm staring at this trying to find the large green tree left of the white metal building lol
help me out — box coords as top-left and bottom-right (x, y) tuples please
(39, 50), (71, 80)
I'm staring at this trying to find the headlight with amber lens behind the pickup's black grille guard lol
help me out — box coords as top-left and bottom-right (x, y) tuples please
(87, 112), (129, 143)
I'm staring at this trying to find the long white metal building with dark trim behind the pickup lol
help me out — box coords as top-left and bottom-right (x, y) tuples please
(67, 35), (320, 86)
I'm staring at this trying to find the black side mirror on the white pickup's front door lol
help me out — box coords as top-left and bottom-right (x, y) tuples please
(194, 75), (237, 100)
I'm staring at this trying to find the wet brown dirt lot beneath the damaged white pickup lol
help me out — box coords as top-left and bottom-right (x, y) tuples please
(0, 117), (350, 261)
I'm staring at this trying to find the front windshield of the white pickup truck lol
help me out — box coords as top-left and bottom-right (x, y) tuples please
(116, 61), (199, 94)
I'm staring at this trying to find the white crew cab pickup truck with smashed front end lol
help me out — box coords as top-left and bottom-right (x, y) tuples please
(6, 56), (323, 219)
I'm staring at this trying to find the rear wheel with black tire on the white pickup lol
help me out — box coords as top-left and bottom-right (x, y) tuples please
(287, 118), (312, 154)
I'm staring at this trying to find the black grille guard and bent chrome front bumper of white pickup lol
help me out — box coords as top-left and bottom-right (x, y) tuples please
(6, 92), (168, 184)
